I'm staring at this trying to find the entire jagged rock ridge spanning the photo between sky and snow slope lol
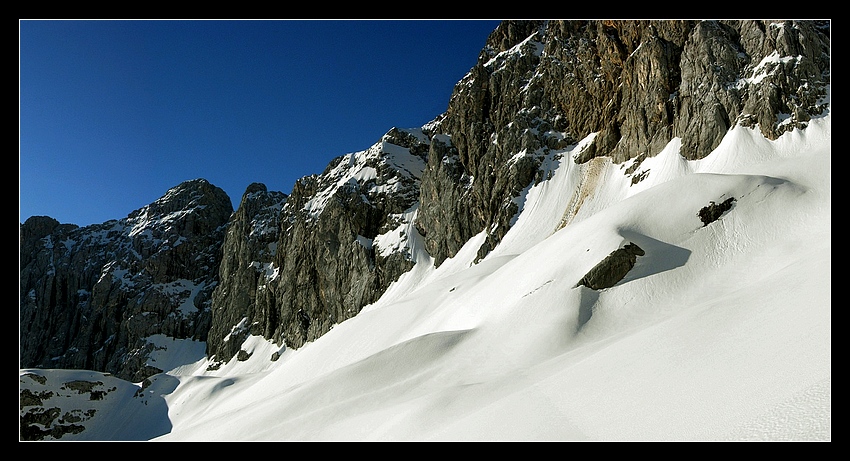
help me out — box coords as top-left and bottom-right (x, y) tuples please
(20, 21), (830, 382)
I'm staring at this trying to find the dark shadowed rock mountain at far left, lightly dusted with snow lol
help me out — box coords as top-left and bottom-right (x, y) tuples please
(20, 179), (233, 382)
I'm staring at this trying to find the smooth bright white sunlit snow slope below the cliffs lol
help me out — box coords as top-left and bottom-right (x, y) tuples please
(24, 110), (831, 441)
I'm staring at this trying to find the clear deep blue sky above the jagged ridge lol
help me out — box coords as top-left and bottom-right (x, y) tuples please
(19, 20), (498, 226)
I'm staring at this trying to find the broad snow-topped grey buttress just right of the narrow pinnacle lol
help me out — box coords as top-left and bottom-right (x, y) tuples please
(267, 129), (428, 347)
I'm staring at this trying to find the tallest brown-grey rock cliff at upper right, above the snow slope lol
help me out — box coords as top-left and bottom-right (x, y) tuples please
(417, 20), (830, 264)
